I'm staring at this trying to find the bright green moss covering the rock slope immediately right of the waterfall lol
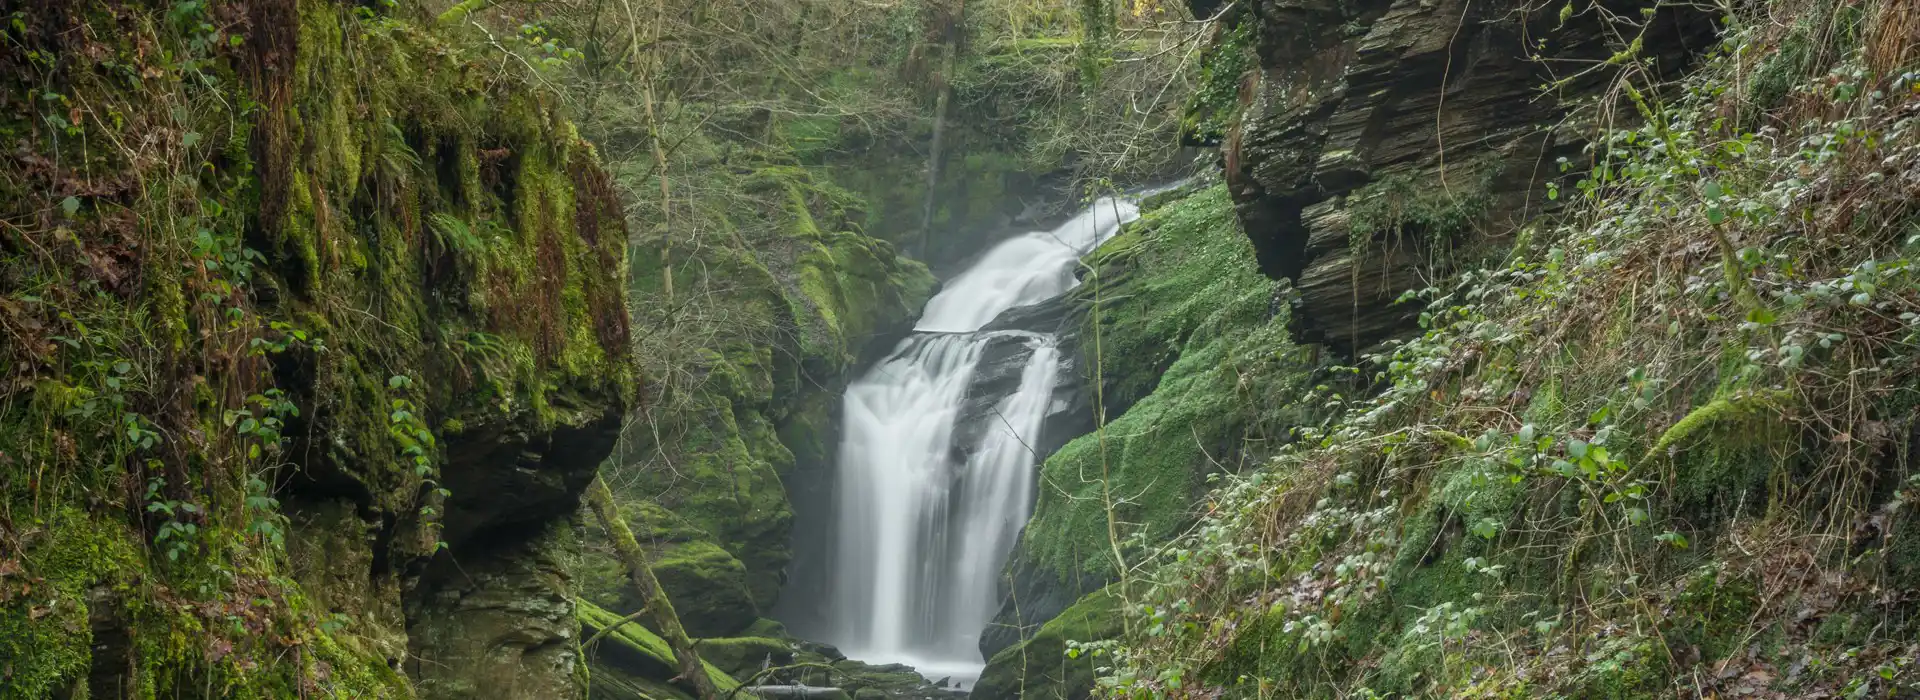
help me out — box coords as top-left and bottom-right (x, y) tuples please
(1025, 186), (1311, 577)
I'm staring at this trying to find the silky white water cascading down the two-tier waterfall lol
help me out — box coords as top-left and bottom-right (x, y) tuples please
(826, 199), (1139, 685)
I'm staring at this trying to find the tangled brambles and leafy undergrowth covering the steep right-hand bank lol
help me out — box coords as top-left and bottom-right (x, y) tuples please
(1069, 2), (1920, 698)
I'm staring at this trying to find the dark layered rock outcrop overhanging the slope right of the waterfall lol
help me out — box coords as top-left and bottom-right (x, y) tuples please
(1194, 0), (1711, 353)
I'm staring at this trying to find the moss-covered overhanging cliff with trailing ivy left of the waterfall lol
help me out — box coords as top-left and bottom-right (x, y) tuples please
(0, 0), (634, 698)
